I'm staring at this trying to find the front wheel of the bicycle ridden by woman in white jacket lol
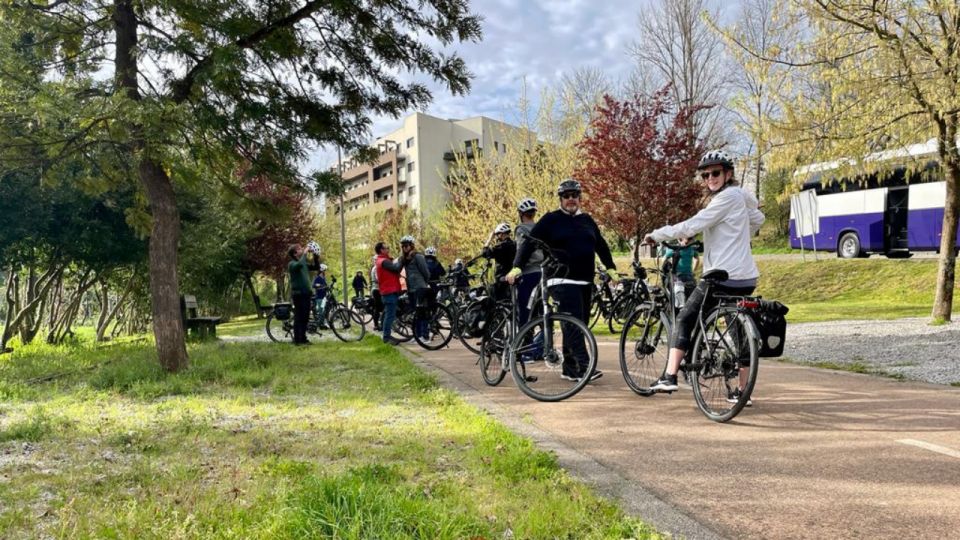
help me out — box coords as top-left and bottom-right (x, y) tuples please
(620, 303), (670, 397)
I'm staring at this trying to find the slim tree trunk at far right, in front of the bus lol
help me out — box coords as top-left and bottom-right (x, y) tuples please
(932, 122), (960, 321)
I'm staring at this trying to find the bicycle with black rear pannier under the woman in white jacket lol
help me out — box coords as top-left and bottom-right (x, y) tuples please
(620, 243), (761, 422)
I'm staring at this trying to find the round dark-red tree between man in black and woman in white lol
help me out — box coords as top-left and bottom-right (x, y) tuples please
(574, 87), (706, 259)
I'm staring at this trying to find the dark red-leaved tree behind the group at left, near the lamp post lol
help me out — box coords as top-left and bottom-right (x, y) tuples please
(243, 176), (316, 301)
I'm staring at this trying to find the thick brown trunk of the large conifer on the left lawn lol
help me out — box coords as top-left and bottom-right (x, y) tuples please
(113, 0), (188, 371)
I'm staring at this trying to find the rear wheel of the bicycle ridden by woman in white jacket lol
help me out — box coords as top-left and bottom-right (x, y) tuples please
(688, 306), (760, 422)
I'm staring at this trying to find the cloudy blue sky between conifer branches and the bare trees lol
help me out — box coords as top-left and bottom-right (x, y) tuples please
(309, 0), (648, 168)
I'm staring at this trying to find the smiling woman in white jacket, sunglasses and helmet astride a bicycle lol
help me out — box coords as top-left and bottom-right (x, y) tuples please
(644, 150), (764, 405)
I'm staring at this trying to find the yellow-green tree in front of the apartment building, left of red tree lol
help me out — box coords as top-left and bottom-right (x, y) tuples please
(434, 92), (590, 257)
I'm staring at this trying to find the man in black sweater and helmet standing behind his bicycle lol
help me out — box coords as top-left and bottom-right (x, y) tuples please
(507, 178), (617, 380)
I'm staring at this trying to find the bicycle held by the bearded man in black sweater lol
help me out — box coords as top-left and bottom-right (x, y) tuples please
(479, 237), (597, 402)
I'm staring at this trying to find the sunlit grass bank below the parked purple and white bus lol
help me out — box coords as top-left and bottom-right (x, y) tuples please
(617, 256), (944, 322)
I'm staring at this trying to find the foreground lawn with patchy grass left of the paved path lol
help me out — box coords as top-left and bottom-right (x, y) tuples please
(0, 339), (652, 539)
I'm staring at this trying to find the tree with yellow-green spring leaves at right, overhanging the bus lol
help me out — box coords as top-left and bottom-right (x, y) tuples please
(746, 0), (960, 320)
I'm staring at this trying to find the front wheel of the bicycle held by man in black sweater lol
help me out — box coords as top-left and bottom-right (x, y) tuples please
(510, 313), (597, 401)
